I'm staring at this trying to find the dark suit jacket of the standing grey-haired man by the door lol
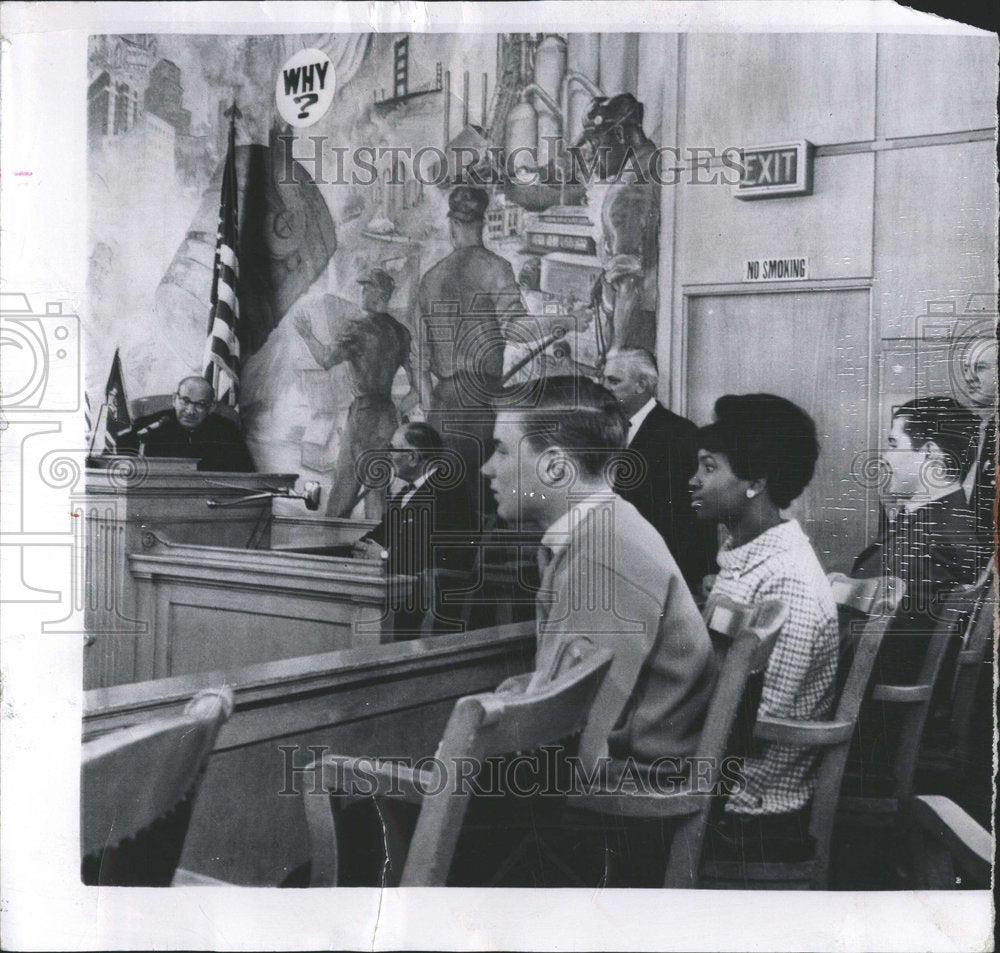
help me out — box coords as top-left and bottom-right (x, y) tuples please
(615, 403), (717, 591)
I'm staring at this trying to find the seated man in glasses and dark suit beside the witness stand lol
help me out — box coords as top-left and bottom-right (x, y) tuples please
(354, 422), (475, 641)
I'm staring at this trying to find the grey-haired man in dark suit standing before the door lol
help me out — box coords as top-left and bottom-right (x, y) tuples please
(604, 348), (716, 594)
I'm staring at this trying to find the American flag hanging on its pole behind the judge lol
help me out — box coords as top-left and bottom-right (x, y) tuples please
(205, 102), (242, 407)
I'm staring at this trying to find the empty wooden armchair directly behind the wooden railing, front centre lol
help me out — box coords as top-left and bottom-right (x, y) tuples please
(303, 640), (611, 887)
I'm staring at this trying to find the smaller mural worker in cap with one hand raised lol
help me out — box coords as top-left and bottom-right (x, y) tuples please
(295, 268), (417, 519)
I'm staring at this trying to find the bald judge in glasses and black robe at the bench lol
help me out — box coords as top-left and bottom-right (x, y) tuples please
(118, 377), (255, 473)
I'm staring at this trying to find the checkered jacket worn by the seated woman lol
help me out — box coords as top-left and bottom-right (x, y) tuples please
(709, 520), (838, 814)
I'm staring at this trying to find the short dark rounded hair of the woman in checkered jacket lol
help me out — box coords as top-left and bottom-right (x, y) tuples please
(698, 394), (819, 509)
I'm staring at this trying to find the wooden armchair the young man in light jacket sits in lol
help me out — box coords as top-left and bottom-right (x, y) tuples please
(567, 598), (788, 887)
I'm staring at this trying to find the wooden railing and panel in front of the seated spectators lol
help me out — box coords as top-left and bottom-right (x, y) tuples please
(83, 623), (535, 886)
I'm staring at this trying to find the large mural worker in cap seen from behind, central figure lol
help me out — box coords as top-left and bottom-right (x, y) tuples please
(414, 185), (524, 513)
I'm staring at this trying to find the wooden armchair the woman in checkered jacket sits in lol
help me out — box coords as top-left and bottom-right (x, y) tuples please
(701, 574), (905, 890)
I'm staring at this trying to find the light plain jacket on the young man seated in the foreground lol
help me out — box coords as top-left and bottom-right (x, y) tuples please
(533, 496), (717, 763)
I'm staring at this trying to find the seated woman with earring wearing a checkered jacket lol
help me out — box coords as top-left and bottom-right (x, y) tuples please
(690, 394), (838, 857)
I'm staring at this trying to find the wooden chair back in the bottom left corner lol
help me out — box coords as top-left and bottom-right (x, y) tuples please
(80, 688), (233, 887)
